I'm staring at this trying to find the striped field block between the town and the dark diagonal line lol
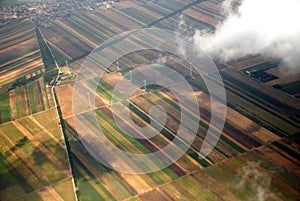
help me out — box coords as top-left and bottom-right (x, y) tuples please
(41, 1), (206, 65)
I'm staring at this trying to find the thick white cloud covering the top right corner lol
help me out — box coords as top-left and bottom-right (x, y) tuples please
(193, 0), (300, 72)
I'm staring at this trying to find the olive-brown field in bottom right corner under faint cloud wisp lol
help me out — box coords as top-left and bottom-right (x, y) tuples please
(133, 141), (300, 200)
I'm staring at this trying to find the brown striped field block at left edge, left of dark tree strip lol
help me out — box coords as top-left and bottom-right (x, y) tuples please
(0, 23), (44, 85)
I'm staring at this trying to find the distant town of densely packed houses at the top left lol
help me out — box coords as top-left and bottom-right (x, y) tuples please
(0, 0), (114, 28)
